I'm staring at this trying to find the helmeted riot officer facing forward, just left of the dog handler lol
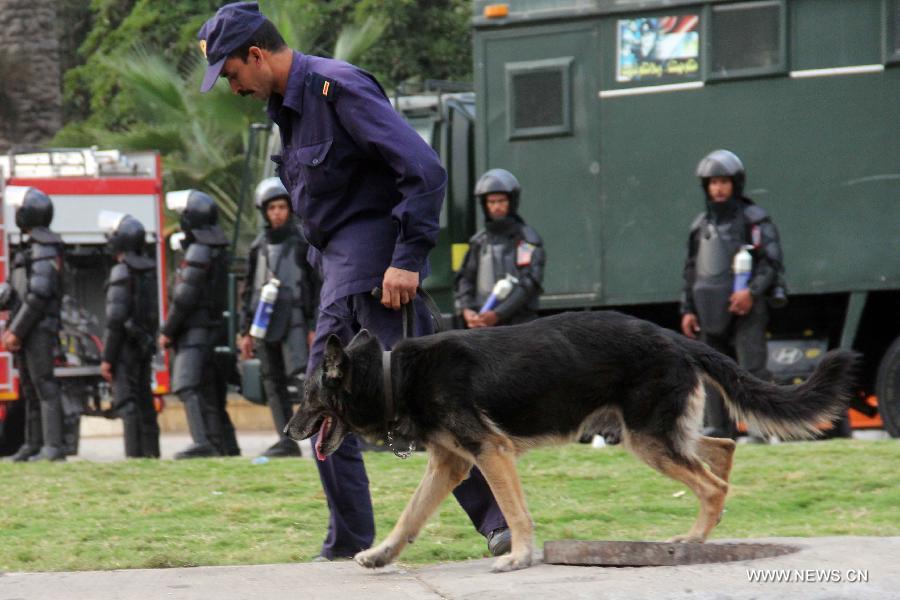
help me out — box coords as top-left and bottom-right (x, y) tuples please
(240, 177), (318, 457)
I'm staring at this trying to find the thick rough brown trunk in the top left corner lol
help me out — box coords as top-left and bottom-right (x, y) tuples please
(0, 0), (62, 153)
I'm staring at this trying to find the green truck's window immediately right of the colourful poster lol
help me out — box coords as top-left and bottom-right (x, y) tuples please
(709, 0), (785, 78)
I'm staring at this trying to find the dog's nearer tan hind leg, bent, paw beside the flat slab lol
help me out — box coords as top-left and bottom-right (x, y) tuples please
(630, 435), (728, 542)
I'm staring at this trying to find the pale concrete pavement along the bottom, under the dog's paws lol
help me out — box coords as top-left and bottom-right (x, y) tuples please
(0, 537), (900, 600)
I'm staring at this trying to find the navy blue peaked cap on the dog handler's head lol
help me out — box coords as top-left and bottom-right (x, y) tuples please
(197, 2), (266, 92)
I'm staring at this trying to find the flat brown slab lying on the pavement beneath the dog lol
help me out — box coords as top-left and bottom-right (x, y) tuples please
(544, 540), (800, 567)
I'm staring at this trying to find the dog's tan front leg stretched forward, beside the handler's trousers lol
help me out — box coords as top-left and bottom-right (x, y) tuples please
(354, 445), (472, 569)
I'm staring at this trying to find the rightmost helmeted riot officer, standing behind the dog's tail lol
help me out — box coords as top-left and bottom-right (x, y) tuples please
(681, 150), (784, 438)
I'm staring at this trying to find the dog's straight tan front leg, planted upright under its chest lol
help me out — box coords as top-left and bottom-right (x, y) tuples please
(475, 438), (534, 573)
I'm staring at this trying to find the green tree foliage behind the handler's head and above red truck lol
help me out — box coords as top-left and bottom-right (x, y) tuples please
(54, 0), (471, 249)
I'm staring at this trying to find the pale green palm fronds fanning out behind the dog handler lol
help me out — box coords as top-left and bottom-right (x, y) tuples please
(87, 7), (386, 252)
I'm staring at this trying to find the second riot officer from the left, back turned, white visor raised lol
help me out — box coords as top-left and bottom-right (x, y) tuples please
(99, 211), (159, 458)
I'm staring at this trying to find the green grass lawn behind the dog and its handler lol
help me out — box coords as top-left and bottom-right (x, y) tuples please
(0, 440), (900, 571)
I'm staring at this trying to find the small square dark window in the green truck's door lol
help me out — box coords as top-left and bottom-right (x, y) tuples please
(506, 57), (572, 139)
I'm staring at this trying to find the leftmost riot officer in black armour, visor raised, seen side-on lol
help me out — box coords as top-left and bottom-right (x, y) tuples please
(3, 187), (66, 462)
